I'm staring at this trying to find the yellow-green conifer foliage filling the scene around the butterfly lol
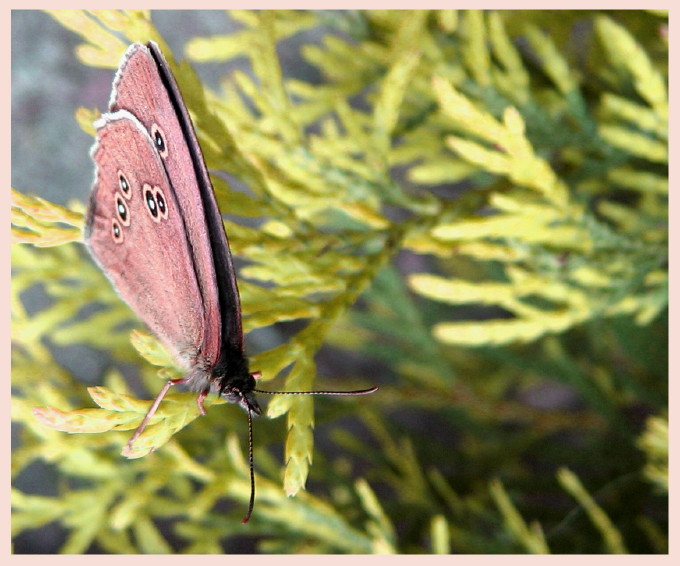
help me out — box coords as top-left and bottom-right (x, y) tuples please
(11, 11), (668, 553)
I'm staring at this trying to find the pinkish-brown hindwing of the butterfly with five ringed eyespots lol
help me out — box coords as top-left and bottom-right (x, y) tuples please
(85, 110), (216, 378)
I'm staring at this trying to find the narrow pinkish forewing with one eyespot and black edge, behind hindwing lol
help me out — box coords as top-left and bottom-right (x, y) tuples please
(109, 42), (244, 364)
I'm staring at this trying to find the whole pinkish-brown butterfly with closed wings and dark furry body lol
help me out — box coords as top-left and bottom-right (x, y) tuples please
(85, 42), (260, 413)
